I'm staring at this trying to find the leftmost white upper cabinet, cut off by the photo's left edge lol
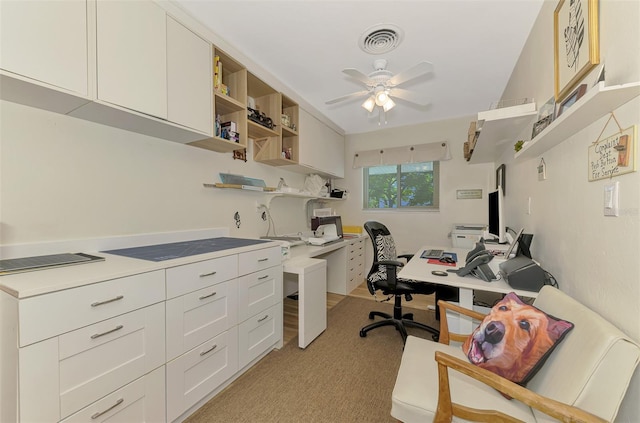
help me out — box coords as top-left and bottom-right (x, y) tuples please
(0, 0), (88, 113)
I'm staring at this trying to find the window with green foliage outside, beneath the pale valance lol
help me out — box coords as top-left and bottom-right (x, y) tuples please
(363, 161), (440, 210)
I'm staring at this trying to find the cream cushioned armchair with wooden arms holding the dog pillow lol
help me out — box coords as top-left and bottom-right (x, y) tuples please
(391, 286), (640, 423)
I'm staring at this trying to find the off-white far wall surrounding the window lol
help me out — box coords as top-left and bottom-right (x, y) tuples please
(335, 116), (495, 255)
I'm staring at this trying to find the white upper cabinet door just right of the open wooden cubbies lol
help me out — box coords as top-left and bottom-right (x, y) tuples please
(298, 109), (344, 178)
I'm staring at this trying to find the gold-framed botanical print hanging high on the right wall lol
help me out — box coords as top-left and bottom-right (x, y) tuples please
(553, 0), (600, 102)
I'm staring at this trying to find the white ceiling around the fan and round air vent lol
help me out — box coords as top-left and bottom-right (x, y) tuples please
(173, 0), (543, 134)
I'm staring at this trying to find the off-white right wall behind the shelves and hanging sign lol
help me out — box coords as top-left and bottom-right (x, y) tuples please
(502, 0), (640, 422)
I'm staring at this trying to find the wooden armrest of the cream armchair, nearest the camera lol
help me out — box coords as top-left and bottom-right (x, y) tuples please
(433, 351), (606, 423)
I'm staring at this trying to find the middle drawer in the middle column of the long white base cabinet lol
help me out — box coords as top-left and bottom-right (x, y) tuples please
(167, 279), (238, 360)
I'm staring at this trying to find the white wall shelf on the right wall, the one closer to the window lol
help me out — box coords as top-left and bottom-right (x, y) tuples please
(469, 103), (537, 163)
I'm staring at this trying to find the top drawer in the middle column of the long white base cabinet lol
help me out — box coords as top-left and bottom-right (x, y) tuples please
(167, 255), (238, 298)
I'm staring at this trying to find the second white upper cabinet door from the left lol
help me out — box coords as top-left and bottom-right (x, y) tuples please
(97, 0), (167, 119)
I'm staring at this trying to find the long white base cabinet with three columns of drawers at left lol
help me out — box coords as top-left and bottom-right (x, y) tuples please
(0, 245), (283, 423)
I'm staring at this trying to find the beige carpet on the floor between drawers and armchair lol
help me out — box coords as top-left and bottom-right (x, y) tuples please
(182, 297), (434, 423)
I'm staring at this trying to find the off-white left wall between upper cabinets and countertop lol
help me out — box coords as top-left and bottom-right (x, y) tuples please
(0, 101), (307, 245)
